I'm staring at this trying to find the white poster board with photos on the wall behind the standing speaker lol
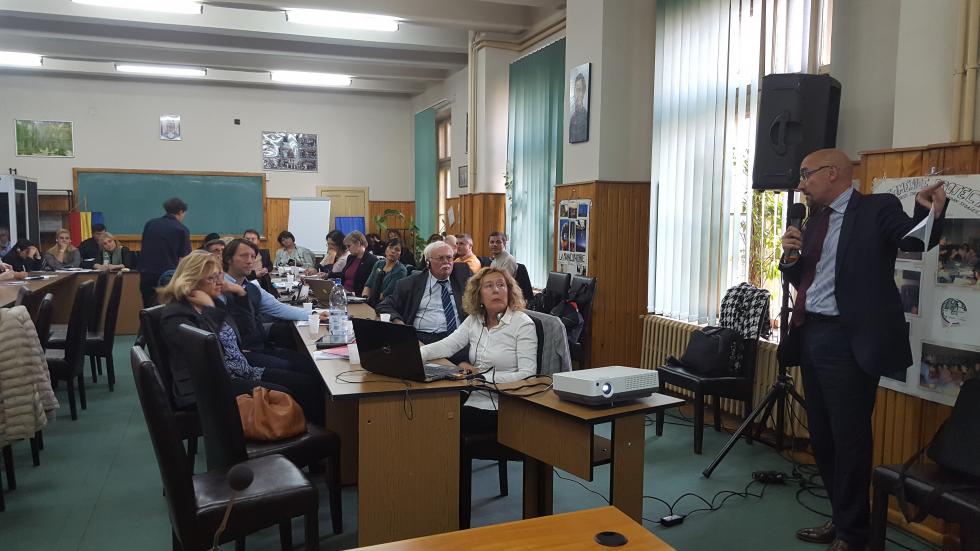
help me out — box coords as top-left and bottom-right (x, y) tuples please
(873, 174), (980, 405)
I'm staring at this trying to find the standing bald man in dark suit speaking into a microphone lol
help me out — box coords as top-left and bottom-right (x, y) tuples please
(779, 149), (946, 551)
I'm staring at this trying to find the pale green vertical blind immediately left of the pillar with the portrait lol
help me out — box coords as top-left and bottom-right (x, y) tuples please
(507, 39), (565, 287)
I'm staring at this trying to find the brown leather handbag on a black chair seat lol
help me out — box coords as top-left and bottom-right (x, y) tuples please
(235, 386), (306, 440)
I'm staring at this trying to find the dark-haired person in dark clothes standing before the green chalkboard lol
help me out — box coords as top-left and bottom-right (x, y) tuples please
(140, 197), (191, 308)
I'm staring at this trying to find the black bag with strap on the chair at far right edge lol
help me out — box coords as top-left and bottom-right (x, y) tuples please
(895, 379), (980, 522)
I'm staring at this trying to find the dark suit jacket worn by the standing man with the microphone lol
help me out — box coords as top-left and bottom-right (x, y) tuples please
(780, 192), (948, 375)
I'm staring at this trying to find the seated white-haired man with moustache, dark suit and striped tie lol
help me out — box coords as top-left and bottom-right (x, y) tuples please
(376, 241), (472, 363)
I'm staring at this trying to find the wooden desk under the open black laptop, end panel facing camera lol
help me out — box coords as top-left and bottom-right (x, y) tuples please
(296, 304), (469, 545)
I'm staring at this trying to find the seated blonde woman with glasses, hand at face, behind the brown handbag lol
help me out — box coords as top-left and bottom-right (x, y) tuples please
(157, 250), (325, 425)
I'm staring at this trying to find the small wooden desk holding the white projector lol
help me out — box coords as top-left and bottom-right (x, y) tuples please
(497, 385), (684, 522)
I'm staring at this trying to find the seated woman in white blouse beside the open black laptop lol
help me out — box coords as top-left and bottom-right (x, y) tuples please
(422, 268), (538, 433)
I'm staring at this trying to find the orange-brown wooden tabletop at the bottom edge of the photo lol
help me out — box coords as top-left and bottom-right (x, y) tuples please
(365, 507), (673, 551)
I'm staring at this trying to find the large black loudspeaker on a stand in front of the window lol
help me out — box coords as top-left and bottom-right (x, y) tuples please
(752, 73), (841, 189)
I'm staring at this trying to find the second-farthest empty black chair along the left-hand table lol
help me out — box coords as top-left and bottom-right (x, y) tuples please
(45, 281), (95, 421)
